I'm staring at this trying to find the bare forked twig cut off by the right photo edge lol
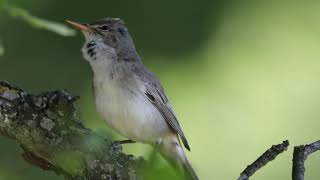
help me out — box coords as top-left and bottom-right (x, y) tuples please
(292, 141), (320, 180)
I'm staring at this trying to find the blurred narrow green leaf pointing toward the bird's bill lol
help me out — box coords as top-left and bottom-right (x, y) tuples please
(5, 5), (76, 36)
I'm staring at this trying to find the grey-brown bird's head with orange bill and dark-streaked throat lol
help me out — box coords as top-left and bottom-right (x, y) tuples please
(66, 18), (136, 64)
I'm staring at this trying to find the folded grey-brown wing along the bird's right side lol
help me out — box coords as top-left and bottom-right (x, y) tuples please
(140, 70), (190, 151)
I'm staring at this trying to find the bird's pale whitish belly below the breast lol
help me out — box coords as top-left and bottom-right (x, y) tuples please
(96, 81), (170, 143)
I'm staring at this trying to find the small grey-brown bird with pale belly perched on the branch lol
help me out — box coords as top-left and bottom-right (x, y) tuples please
(66, 18), (199, 180)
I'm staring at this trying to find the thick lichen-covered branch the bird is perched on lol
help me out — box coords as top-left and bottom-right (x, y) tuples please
(0, 82), (144, 180)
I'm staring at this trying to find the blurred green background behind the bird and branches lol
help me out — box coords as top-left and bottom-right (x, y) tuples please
(0, 0), (320, 180)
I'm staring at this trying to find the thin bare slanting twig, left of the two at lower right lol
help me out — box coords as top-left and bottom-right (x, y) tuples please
(237, 140), (289, 180)
